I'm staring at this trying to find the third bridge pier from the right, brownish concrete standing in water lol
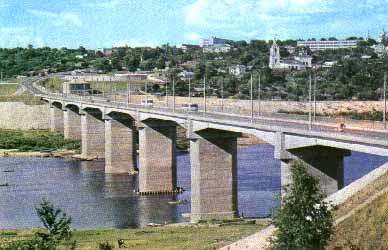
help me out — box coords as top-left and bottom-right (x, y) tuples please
(139, 121), (176, 192)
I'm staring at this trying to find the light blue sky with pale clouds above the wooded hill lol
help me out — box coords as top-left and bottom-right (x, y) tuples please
(0, 0), (388, 49)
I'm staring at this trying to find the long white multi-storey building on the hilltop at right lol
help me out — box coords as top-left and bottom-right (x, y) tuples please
(297, 40), (360, 51)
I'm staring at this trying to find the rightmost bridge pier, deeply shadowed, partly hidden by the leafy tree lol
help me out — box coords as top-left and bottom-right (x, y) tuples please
(275, 133), (351, 196)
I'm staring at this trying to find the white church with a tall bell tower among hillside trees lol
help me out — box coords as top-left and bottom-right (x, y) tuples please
(269, 39), (312, 71)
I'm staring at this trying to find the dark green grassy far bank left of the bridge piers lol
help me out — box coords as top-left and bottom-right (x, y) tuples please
(0, 130), (80, 151)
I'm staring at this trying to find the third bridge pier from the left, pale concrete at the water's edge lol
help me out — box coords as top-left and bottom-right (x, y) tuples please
(81, 110), (105, 158)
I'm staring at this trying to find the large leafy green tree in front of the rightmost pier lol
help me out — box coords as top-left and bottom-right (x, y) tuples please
(271, 161), (334, 250)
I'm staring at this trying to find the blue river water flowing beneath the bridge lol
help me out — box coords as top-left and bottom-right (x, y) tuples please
(0, 144), (388, 228)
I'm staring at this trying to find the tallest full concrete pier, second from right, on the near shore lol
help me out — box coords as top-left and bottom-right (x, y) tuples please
(190, 131), (239, 222)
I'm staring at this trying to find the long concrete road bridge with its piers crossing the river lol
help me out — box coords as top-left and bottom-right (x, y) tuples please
(23, 78), (388, 222)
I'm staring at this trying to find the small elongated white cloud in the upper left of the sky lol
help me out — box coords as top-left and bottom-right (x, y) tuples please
(27, 9), (82, 27)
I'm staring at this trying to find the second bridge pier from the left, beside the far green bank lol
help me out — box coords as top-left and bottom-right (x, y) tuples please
(63, 108), (82, 140)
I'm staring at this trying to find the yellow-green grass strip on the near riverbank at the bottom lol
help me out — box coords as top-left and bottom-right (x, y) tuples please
(0, 221), (267, 250)
